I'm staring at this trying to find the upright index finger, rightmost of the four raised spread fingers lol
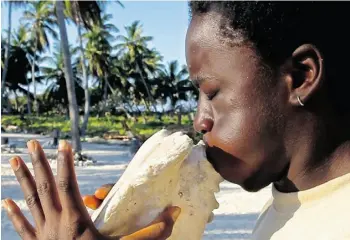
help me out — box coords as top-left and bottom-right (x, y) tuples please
(57, 140), (84, 210)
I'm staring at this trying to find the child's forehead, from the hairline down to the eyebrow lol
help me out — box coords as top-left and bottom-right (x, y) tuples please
(186, 12), (256, 78)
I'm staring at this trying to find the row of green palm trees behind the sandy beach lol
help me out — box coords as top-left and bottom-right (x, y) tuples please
(1, 0), (198, 152)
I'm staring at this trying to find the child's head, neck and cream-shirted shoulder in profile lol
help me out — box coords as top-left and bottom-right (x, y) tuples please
(4, 1), (350, 240)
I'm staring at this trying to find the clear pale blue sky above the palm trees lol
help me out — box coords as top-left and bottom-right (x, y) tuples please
(1, 1), (189, 94)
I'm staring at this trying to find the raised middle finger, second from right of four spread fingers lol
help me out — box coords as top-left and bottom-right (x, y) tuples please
(27, 140), (60, 216)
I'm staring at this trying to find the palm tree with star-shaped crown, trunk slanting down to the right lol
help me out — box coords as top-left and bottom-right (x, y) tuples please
(116, 21), (162, 111)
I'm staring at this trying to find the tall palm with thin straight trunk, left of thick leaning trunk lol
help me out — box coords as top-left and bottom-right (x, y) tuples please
(23, 1), (58, 114)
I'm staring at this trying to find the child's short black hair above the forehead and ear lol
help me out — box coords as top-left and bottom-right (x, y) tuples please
(189, 1), (350, 114)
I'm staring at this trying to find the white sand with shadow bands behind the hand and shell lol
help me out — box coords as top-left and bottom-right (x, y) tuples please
(1, 134), (271, 240)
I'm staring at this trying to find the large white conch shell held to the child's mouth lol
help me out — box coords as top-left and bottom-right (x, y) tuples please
(92, 130), (223, 240)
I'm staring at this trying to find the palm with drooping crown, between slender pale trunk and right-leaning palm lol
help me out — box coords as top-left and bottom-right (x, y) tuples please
(83, 14), (118, 111)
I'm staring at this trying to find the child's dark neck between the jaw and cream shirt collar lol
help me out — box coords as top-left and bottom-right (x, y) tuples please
(275, 113), (350, 192)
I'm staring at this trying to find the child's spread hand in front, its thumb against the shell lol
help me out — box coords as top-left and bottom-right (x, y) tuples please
(3, 141), (180, 240)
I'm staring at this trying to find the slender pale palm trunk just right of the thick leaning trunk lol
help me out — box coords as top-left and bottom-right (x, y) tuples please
(78, 22), (90, 136)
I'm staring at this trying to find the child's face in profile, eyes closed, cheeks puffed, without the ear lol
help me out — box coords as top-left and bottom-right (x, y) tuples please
(186, 14), (288, 191)
